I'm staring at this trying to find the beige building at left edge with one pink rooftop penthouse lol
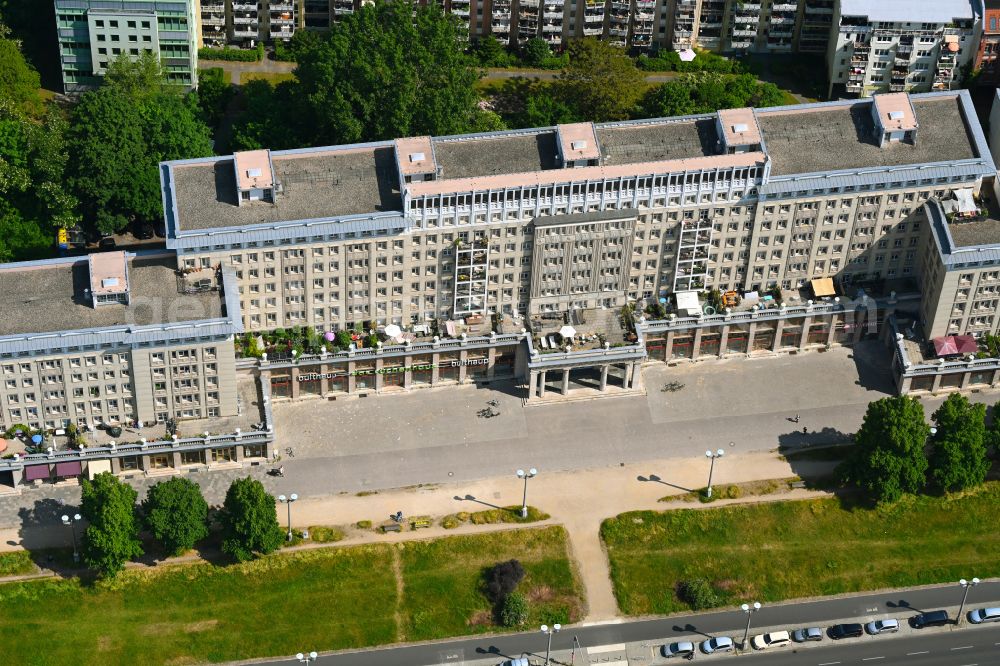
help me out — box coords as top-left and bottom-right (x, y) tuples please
(0, 251), (242, 430)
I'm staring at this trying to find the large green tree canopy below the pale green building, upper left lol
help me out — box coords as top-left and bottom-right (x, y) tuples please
(68, 62), (212, 233)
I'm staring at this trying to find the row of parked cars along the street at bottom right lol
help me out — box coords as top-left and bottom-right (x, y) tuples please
(660, 608), (1000, 659)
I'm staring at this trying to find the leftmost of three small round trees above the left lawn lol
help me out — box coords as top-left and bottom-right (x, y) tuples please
(80, 472), (142, 577)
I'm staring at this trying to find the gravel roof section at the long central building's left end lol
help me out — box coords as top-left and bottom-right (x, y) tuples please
(173, 147), (402, 232)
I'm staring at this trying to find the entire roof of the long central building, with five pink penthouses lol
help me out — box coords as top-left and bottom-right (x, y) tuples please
(161, 91), (993, 243)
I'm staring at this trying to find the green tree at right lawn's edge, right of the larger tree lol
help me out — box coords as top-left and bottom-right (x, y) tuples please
(930, 393), (990, 492)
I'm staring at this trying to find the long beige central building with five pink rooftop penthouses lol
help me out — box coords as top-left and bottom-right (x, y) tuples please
(162, 91), (994, 338)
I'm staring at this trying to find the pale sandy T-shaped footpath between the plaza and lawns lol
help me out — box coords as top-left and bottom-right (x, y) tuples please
(0, 452), (831, 622)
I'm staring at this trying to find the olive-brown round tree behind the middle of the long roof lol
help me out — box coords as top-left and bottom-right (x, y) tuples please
(559, 37), (644, 122)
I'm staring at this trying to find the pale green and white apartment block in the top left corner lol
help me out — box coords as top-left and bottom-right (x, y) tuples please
(54, 0), (199, 93)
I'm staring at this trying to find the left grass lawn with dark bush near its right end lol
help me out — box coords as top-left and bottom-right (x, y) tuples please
(0, 528), (580, 665)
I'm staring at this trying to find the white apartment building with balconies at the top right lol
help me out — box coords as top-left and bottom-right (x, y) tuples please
(827, 0), (982, 97)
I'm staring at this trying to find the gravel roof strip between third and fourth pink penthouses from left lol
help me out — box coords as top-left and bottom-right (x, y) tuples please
(597, 118), (719, 164)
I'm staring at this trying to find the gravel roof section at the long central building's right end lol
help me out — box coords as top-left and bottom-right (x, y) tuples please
(757, 97), (976, 176)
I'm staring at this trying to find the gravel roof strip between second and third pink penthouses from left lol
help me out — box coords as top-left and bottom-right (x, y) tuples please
(434, 131), (558, 180)
